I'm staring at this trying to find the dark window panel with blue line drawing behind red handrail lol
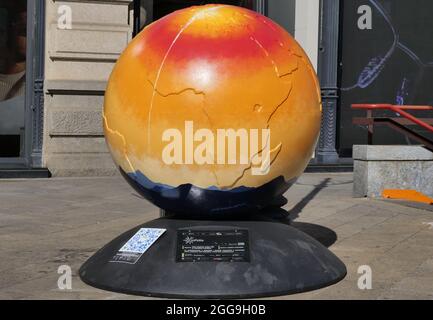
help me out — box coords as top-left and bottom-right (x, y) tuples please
(338, 0), (433, 157)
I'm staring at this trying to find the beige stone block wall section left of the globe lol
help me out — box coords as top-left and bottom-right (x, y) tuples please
(42, 0), (133, 176)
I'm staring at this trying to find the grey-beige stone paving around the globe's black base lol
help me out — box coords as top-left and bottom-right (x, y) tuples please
(0, 173), (433, 299)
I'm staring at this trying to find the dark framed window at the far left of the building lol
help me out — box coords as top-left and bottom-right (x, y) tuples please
(0, 0), (45, 172)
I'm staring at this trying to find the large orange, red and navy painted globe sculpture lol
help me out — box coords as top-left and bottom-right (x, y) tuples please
(103, 5), (322, 215)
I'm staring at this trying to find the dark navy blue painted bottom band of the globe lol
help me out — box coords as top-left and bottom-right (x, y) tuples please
(119, 168), (296, 218)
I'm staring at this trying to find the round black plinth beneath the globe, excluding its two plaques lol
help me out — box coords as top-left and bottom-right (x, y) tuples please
(79, 218), (346, 298)
